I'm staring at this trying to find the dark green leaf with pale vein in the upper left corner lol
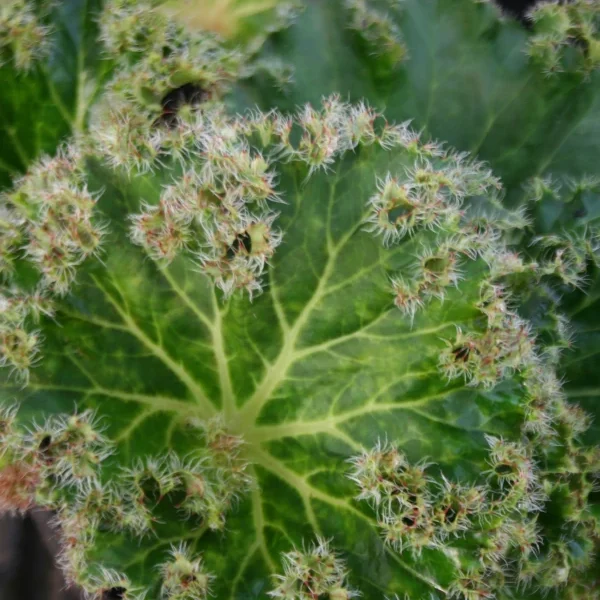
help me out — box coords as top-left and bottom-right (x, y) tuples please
(0, 0), (106, 187)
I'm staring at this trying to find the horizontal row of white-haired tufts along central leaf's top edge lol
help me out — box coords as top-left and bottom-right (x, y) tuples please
(98, 88), (446, 178)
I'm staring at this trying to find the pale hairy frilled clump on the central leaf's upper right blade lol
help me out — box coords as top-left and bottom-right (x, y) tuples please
(366, 152), (500, 319)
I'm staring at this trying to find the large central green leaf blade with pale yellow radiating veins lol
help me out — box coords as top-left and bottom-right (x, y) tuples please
(7, 143), (510, 598)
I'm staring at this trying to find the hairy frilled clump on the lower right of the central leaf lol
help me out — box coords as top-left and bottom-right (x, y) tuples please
(349, 437), (588, 599)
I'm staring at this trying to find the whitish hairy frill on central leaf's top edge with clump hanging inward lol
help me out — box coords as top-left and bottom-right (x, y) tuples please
(125, 95), (424, 295)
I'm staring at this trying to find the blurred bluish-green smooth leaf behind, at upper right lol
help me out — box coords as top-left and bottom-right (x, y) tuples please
(243, 0), (600, 186)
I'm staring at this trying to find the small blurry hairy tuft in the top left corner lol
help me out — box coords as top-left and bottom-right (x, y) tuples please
(0, 0), (50, 71)
